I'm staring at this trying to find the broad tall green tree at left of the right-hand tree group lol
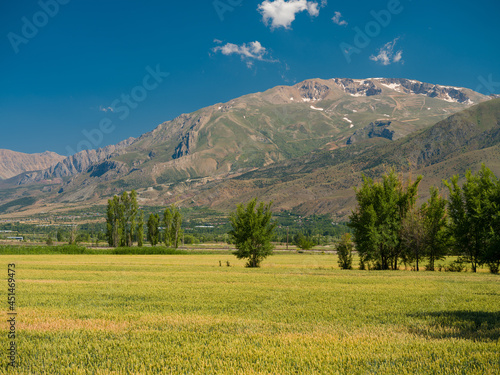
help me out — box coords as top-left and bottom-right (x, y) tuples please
(349, 169), (422, 269)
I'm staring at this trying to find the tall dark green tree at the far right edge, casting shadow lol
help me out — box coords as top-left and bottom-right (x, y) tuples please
(445, 164), (499, 272)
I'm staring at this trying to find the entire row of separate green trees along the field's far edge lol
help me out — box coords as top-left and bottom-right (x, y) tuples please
(102, 164), (500, 273)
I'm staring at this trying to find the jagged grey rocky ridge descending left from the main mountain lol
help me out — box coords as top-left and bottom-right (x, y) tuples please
(16, 138), (135, 185)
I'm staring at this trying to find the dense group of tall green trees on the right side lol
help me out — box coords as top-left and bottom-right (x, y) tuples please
(349, 164), (500, 273)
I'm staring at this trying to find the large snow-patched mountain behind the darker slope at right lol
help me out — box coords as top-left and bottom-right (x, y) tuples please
(0, 78), (490, 217)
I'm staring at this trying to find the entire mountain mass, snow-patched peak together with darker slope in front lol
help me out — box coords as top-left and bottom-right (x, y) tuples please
(0, 78), (500, 218)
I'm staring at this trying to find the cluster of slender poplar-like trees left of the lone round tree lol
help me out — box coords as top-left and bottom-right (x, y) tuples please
(106, 190), (183, 248)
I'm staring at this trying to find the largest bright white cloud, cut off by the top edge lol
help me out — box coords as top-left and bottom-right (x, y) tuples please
(257, 0), (320, 29)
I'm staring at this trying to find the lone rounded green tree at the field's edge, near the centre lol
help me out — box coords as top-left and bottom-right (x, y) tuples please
(229, 199), (276, 267)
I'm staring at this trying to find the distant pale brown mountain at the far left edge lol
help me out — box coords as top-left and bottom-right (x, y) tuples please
(0, 150), (64, 179)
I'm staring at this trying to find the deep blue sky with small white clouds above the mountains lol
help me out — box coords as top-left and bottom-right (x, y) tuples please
(0, 0), (500, 155)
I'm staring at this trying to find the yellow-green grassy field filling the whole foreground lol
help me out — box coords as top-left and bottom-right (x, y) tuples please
(0, 254), (500, 374)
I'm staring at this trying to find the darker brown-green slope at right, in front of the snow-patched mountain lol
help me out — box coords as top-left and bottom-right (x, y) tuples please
(170, 99), (500, 218)
